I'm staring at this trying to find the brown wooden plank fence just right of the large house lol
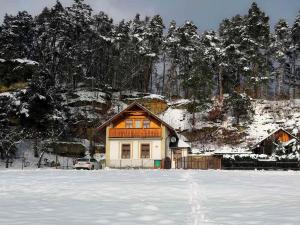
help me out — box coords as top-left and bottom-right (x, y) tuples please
(175, 156), (222, 170)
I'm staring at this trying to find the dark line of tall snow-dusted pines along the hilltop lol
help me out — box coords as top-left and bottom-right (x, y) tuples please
(0, 0), (300, 110)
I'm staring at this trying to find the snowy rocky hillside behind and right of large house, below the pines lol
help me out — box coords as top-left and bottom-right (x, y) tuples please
(105, 92), (300, 152)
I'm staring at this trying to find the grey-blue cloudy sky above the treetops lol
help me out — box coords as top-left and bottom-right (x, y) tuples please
(0, 0), (300, 31)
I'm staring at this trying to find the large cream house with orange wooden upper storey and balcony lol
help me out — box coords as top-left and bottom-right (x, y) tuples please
(98, 102), (188, 168)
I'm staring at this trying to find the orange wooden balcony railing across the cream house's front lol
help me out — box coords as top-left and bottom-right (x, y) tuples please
(109, 128), (161, 138)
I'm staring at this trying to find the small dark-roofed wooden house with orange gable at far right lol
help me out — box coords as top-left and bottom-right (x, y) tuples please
(251, 128), (298, 155)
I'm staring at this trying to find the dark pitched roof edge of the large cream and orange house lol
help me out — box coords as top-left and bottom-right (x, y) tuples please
(97, 101), (177, 136)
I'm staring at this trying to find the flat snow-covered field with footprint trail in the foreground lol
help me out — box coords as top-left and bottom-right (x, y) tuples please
(0, 170), (300, 225)
